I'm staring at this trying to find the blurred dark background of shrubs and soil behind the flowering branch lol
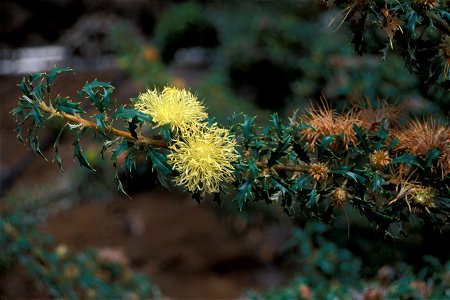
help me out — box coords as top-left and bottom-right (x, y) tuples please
(0, 0), (450, 299)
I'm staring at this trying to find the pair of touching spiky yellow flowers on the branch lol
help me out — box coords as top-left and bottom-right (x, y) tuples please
(134, 87), (238, 194)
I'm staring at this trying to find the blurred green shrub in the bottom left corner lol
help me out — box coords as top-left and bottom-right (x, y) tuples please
(0, 208), (161, 299)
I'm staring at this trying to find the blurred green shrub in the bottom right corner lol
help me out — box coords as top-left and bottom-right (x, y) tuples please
(248, 223), (450, 300)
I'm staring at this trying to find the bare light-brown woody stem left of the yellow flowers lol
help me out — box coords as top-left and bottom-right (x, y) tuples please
(40, 102), (168, 148)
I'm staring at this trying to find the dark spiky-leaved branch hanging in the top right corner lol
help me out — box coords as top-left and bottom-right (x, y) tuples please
(330, 0), (450, 111)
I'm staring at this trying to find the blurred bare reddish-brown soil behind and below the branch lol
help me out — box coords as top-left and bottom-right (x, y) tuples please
(0, 71), (287, 299)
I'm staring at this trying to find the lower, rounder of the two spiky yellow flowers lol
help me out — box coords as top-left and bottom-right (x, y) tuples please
(167, 124), (238, 194)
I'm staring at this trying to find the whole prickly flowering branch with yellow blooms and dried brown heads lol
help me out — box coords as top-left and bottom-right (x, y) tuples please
(12, 68), (450, 234)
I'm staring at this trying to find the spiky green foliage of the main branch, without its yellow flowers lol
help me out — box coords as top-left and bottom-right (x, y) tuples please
(12, 67), (450, 236)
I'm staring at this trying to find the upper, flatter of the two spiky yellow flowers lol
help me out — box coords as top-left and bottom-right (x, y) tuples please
(134, 87), (208, 131)
